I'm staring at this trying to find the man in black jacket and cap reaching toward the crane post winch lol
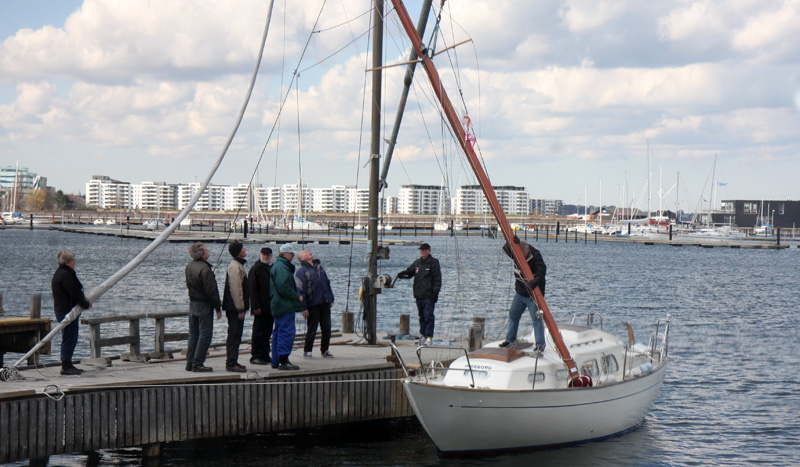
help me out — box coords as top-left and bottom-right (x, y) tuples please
(397, 243), (442, 345)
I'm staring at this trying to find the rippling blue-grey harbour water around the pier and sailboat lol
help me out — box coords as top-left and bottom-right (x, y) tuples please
(0, 230), (800, 466)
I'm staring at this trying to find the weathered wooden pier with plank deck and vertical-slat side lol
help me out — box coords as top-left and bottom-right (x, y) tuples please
(0, 334), (450, 464)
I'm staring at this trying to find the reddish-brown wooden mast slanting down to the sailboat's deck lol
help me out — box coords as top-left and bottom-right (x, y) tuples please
(392, 0), (580, 380)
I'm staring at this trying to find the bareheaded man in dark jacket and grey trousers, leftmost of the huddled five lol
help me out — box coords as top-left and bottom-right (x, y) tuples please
(186, 243), (222, 372)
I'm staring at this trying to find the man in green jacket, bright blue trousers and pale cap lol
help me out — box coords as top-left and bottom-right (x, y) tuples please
(270, 243), (304, 370)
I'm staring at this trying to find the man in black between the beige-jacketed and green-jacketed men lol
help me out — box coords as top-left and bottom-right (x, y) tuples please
(247, 247), (275, 365)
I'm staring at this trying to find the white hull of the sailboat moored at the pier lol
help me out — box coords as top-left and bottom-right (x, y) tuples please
(403, 361), (667, 454)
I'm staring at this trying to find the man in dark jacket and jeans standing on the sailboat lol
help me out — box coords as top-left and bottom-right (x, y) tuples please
(500, 236), (547, 351)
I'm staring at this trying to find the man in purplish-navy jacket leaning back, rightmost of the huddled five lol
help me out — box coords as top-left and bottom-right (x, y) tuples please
(294, 250), (333, 358)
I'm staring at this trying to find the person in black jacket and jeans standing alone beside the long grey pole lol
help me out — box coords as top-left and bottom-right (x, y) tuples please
(51, 250), (92, 375)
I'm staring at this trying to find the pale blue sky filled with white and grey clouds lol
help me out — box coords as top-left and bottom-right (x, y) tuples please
(0, 0), (800, 211)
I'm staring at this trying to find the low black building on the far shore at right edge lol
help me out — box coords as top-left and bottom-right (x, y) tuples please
(700, 199), (800, 228)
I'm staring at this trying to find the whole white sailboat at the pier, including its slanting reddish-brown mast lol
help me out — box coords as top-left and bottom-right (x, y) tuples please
(376, 0), (669, 453)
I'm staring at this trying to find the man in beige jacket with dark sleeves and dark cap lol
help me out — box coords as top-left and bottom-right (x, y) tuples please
(222, 242), (250, 373)
